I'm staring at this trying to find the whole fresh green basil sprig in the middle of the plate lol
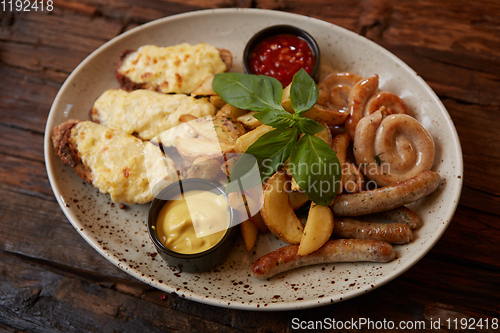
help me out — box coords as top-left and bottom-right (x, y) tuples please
(212, 69), (341, 206)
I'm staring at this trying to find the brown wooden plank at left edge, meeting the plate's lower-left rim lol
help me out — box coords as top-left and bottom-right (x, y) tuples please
(0, 185), (133, 279)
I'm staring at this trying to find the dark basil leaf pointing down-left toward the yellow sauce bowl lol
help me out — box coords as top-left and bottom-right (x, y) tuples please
(230, 127), (298, 182)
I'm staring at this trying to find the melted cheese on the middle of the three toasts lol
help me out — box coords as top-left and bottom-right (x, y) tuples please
(94, 89), (216, 140)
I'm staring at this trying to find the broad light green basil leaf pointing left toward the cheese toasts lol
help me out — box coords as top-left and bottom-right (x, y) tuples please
(212, 73), (283, 111)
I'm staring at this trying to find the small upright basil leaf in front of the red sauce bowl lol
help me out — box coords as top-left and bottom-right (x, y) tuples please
(290, 68), (319, 114)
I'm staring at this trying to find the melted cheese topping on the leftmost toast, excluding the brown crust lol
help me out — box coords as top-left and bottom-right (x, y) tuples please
(70, 121), (173, 204)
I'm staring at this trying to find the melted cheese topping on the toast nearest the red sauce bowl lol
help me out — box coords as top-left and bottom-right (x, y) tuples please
(119, 43), (226, 94)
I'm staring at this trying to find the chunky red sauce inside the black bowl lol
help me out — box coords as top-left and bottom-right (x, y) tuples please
(250, 34), (315, 87)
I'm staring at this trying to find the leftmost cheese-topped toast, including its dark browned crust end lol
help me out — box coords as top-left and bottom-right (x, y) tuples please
(51, 120), (178, 204)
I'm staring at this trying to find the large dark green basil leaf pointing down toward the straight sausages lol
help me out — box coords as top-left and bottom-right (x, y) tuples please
(288, 134), (342, 206)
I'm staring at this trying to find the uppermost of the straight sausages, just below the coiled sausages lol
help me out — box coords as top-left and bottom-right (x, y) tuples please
(332, 171), (441, 216)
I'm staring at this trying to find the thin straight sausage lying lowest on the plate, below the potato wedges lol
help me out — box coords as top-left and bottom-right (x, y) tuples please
(252, 239), (396, 279)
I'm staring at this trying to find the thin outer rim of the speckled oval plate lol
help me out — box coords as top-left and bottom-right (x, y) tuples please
(44, 8), (463, 311)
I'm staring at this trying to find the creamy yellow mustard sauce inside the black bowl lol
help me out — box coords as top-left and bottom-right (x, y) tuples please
(156, 190), (230, 254)
